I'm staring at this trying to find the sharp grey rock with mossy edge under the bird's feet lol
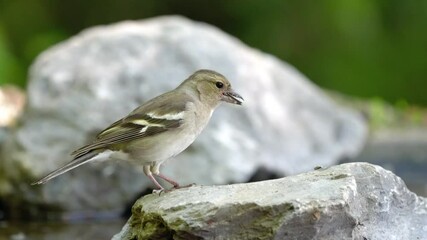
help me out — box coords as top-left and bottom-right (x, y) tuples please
(113, 163), (427, 240)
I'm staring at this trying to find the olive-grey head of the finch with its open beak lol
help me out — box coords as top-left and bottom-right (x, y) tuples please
(181, 69), (243, 105)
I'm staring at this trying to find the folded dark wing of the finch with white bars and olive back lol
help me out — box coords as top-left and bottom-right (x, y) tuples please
(72, 93), (191, 158)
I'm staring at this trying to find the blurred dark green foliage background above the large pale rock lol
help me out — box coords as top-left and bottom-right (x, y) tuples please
(0, 0), (427, 105)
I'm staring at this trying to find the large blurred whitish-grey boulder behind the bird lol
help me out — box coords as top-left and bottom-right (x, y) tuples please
(0, 17), (366, 217)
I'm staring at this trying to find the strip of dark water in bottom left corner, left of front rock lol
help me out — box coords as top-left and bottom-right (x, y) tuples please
(0, 219), (126, 240)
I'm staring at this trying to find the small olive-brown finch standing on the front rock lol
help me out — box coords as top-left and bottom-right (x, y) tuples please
(32, 69), (244, 191)
